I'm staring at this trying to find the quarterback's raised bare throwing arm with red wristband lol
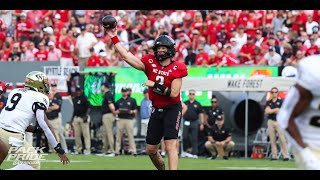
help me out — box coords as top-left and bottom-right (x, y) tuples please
(106, 27), (145, 71)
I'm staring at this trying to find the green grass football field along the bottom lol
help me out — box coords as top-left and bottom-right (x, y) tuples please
(0, 154), (295, 170)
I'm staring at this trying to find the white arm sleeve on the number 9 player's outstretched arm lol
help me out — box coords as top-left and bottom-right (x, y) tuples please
(35, 105), (58, 147)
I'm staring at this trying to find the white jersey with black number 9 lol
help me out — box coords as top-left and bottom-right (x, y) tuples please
(0, 88), (49, 133)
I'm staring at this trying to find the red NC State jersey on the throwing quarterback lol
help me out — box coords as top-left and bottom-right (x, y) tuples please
(141, 54), (188, 108)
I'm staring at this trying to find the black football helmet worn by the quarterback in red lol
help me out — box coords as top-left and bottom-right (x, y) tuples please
(153, 35), (176, 61)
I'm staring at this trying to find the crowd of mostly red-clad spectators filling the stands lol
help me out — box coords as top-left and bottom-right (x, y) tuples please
(0, 10), (320, 67)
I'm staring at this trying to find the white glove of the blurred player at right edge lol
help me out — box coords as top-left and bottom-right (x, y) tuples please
(300, 148), (320, 170)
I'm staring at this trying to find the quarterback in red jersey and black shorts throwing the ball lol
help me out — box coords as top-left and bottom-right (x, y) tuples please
(106, 28), (188, 170)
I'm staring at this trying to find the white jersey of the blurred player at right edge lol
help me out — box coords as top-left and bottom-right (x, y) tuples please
(277, 55), (320, 150)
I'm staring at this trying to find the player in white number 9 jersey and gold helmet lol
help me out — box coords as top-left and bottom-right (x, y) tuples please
(0, 71), (69, 170)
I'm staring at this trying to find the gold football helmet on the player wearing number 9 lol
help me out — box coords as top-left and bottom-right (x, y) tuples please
(24, 71), (50, 95)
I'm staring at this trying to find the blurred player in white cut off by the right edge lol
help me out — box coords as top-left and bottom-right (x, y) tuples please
(277, 55), (320, 170)
